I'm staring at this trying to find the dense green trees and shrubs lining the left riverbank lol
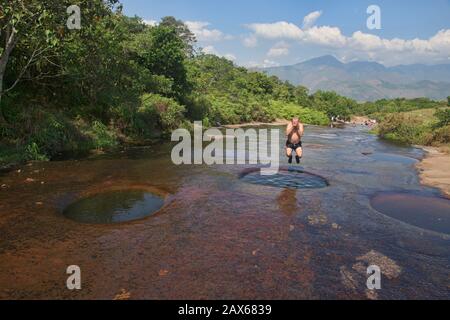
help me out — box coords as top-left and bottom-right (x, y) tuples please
(0, 0), (450, 164)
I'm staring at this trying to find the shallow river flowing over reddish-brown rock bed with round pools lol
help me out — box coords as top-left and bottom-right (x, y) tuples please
(0, 127), (450, 299)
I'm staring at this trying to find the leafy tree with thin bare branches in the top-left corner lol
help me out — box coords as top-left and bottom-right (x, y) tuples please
(0, 0), (118, 123)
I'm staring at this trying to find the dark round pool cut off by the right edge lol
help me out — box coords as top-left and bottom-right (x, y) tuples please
(370, 193), (450, 234)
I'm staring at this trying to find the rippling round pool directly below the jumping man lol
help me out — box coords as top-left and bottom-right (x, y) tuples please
(241, 169), (329, 189)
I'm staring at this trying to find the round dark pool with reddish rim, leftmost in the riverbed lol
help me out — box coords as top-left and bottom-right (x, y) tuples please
(63, 190), (164, 224)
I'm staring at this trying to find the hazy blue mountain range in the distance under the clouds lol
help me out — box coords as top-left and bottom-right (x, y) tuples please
(258, 56), (450, 101)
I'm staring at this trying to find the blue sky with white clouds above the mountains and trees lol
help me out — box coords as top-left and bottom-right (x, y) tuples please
(121, 0), (450, 66)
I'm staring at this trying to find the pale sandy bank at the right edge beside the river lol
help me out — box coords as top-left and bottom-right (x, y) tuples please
(417, 147), (450, 197)
